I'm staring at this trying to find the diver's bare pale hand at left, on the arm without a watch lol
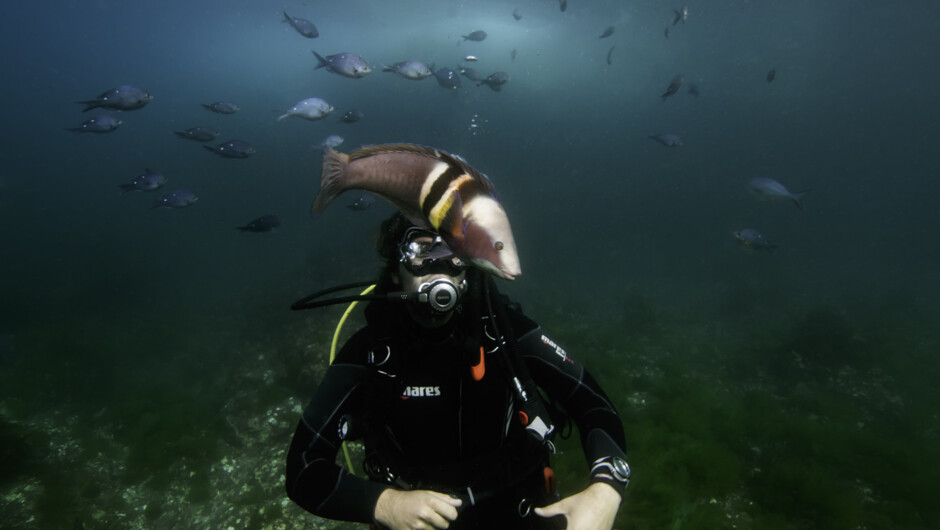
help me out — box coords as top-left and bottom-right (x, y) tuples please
(375, 488), (462, 530)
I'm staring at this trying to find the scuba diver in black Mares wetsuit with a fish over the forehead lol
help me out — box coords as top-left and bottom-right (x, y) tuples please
(286, 213), (630, 530)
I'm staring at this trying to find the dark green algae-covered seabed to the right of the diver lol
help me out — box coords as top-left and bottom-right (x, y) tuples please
(542, 289), (940, 530)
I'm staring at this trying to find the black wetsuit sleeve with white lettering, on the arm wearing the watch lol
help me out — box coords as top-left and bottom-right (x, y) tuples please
(514, 313), (626, 493)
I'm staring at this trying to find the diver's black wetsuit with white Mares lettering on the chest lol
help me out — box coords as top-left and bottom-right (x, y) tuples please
(286, 290), (624, 528)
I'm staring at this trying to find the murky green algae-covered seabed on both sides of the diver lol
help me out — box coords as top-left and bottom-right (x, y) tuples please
(0, 287), (940, 530)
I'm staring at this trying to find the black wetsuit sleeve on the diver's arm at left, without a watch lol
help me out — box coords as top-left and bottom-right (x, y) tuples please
(286, 336), (386, 523)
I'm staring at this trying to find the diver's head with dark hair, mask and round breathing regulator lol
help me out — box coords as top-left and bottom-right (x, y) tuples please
(377, 213), (468, 327)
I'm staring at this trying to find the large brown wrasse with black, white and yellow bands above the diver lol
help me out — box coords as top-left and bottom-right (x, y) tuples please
(311, 140), (522, 280)
